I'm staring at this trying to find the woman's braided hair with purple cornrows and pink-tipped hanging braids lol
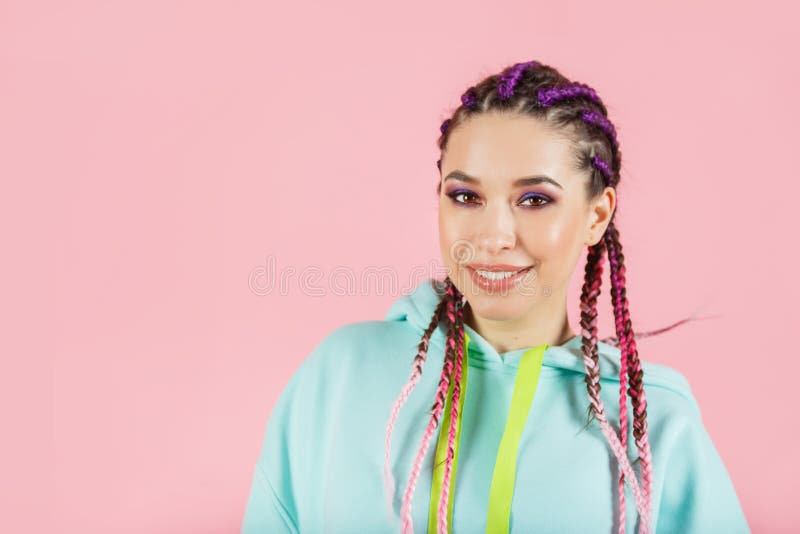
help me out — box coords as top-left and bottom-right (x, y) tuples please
(384, 61), (693, 534)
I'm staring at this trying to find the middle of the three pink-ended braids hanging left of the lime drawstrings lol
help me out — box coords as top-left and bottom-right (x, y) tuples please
(400, 278), (459, 534)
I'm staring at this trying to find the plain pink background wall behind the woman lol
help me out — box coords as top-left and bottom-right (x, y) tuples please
(0, 0), (800, 533)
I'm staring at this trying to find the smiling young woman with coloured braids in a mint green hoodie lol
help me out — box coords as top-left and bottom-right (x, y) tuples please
(242, 61), (750, 534)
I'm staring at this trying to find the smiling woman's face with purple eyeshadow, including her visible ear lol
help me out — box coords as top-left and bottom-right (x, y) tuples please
(439, 113), (615, 320)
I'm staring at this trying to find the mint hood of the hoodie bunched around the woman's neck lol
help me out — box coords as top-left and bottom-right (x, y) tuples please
(384, 278), (691, 398)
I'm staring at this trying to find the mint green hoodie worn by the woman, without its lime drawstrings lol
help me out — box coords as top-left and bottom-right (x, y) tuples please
(242, 280), (750, 534)
